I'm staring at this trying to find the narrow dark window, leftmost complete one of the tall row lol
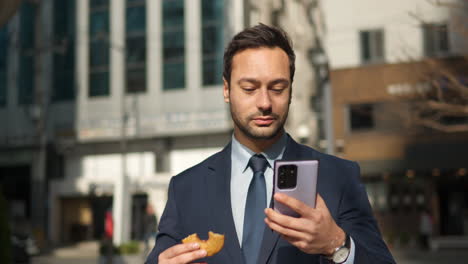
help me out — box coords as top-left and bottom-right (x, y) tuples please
(18, 1), (36, 105)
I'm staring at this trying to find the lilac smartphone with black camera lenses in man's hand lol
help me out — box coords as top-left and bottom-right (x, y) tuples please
(273, 160), (319, 217)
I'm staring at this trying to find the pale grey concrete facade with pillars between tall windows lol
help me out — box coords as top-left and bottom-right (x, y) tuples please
(77, 0), (231, 141)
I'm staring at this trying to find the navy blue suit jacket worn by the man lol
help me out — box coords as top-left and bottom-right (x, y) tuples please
(146, 136), (394, 264)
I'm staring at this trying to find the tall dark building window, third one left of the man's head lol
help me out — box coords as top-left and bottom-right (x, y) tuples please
(126, 0), (146, 93)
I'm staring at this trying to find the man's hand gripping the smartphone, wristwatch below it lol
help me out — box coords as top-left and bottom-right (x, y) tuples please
(265, 193), (346, 255)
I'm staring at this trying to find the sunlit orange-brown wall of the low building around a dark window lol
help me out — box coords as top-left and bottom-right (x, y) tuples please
(331, 60), (466, 165)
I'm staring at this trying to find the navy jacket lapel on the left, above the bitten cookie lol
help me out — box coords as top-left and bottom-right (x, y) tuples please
(205, 143), (244, 263)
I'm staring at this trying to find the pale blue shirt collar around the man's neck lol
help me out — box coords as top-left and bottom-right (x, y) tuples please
(231, 132), (287, 172)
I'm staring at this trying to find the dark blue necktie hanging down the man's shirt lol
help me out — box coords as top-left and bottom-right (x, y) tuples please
(242, 154), (268, 264)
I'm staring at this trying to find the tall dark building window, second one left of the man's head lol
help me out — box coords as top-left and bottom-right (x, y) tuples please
(163, 0), (185, 90)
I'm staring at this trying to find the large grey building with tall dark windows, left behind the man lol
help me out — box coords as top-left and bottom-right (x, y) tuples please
(0, 0), (317, 250)
